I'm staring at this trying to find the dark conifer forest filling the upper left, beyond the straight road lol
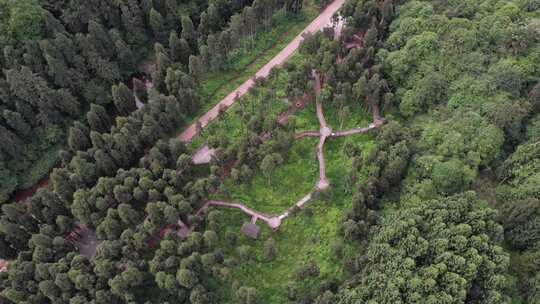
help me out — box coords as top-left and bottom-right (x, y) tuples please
(0, 0), (301, 201)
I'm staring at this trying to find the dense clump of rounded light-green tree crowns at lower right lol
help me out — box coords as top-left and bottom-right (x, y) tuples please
(337, 192), (509, 304)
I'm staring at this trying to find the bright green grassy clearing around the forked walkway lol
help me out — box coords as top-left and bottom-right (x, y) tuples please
(202, 95), (374, 304)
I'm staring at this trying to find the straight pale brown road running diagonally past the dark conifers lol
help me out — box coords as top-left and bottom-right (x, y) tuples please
(178, 0), (345, 142)
